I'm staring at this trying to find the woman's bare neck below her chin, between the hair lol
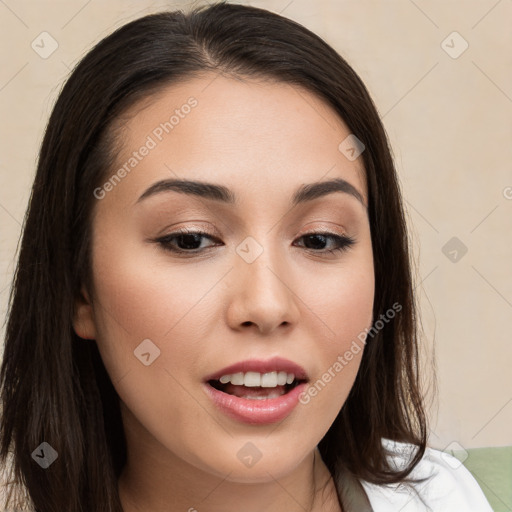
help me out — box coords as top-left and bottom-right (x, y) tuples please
(118, 410), (340, 512)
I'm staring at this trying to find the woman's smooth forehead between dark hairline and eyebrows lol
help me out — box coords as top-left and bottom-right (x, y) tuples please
(99, 74), (367, 210)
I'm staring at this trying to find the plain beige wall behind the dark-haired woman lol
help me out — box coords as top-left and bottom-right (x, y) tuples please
(0, 0), (512, 449)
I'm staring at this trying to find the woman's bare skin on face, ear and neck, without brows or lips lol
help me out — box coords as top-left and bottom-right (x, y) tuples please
(74, 74), (374, 512)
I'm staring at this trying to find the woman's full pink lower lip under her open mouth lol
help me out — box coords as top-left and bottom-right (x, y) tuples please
(204, 382), (307, 425)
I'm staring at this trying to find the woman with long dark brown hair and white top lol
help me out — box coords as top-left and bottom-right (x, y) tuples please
(0, 3), (491, 512)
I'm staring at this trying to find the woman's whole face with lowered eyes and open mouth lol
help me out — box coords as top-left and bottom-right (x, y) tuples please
(74, 75), (374, 482)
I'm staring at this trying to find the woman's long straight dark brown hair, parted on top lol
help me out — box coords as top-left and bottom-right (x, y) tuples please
(0, 2), (427, 512)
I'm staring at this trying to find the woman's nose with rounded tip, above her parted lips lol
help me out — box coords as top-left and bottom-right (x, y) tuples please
(227, 241), (300, 334)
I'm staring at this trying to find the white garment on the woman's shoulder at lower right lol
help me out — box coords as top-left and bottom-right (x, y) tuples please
(361, 439), (492, 512)
